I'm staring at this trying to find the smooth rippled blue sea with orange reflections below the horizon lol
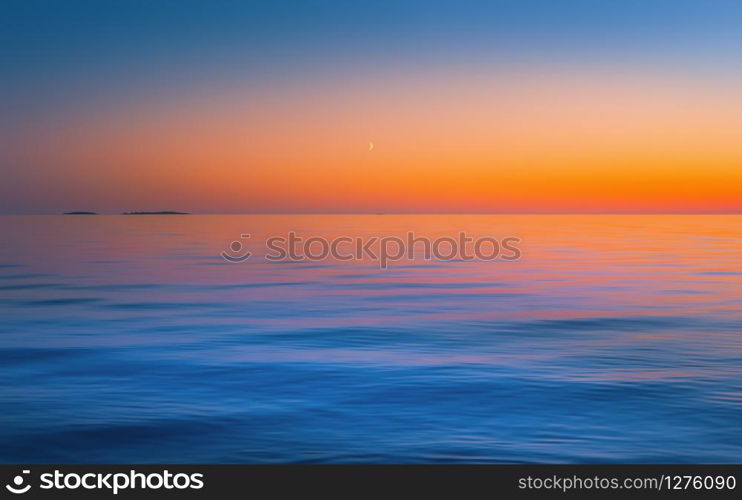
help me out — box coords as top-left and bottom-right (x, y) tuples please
(0, 215), (742, 463)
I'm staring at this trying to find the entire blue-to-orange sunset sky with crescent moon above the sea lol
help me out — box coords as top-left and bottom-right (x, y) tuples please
(0, 0), (742, 214)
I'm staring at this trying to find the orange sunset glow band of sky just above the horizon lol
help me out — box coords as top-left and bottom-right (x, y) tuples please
(4, 67), (742, 212)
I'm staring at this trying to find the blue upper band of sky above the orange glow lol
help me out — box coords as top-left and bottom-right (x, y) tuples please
(5, 0), (742, 86)
